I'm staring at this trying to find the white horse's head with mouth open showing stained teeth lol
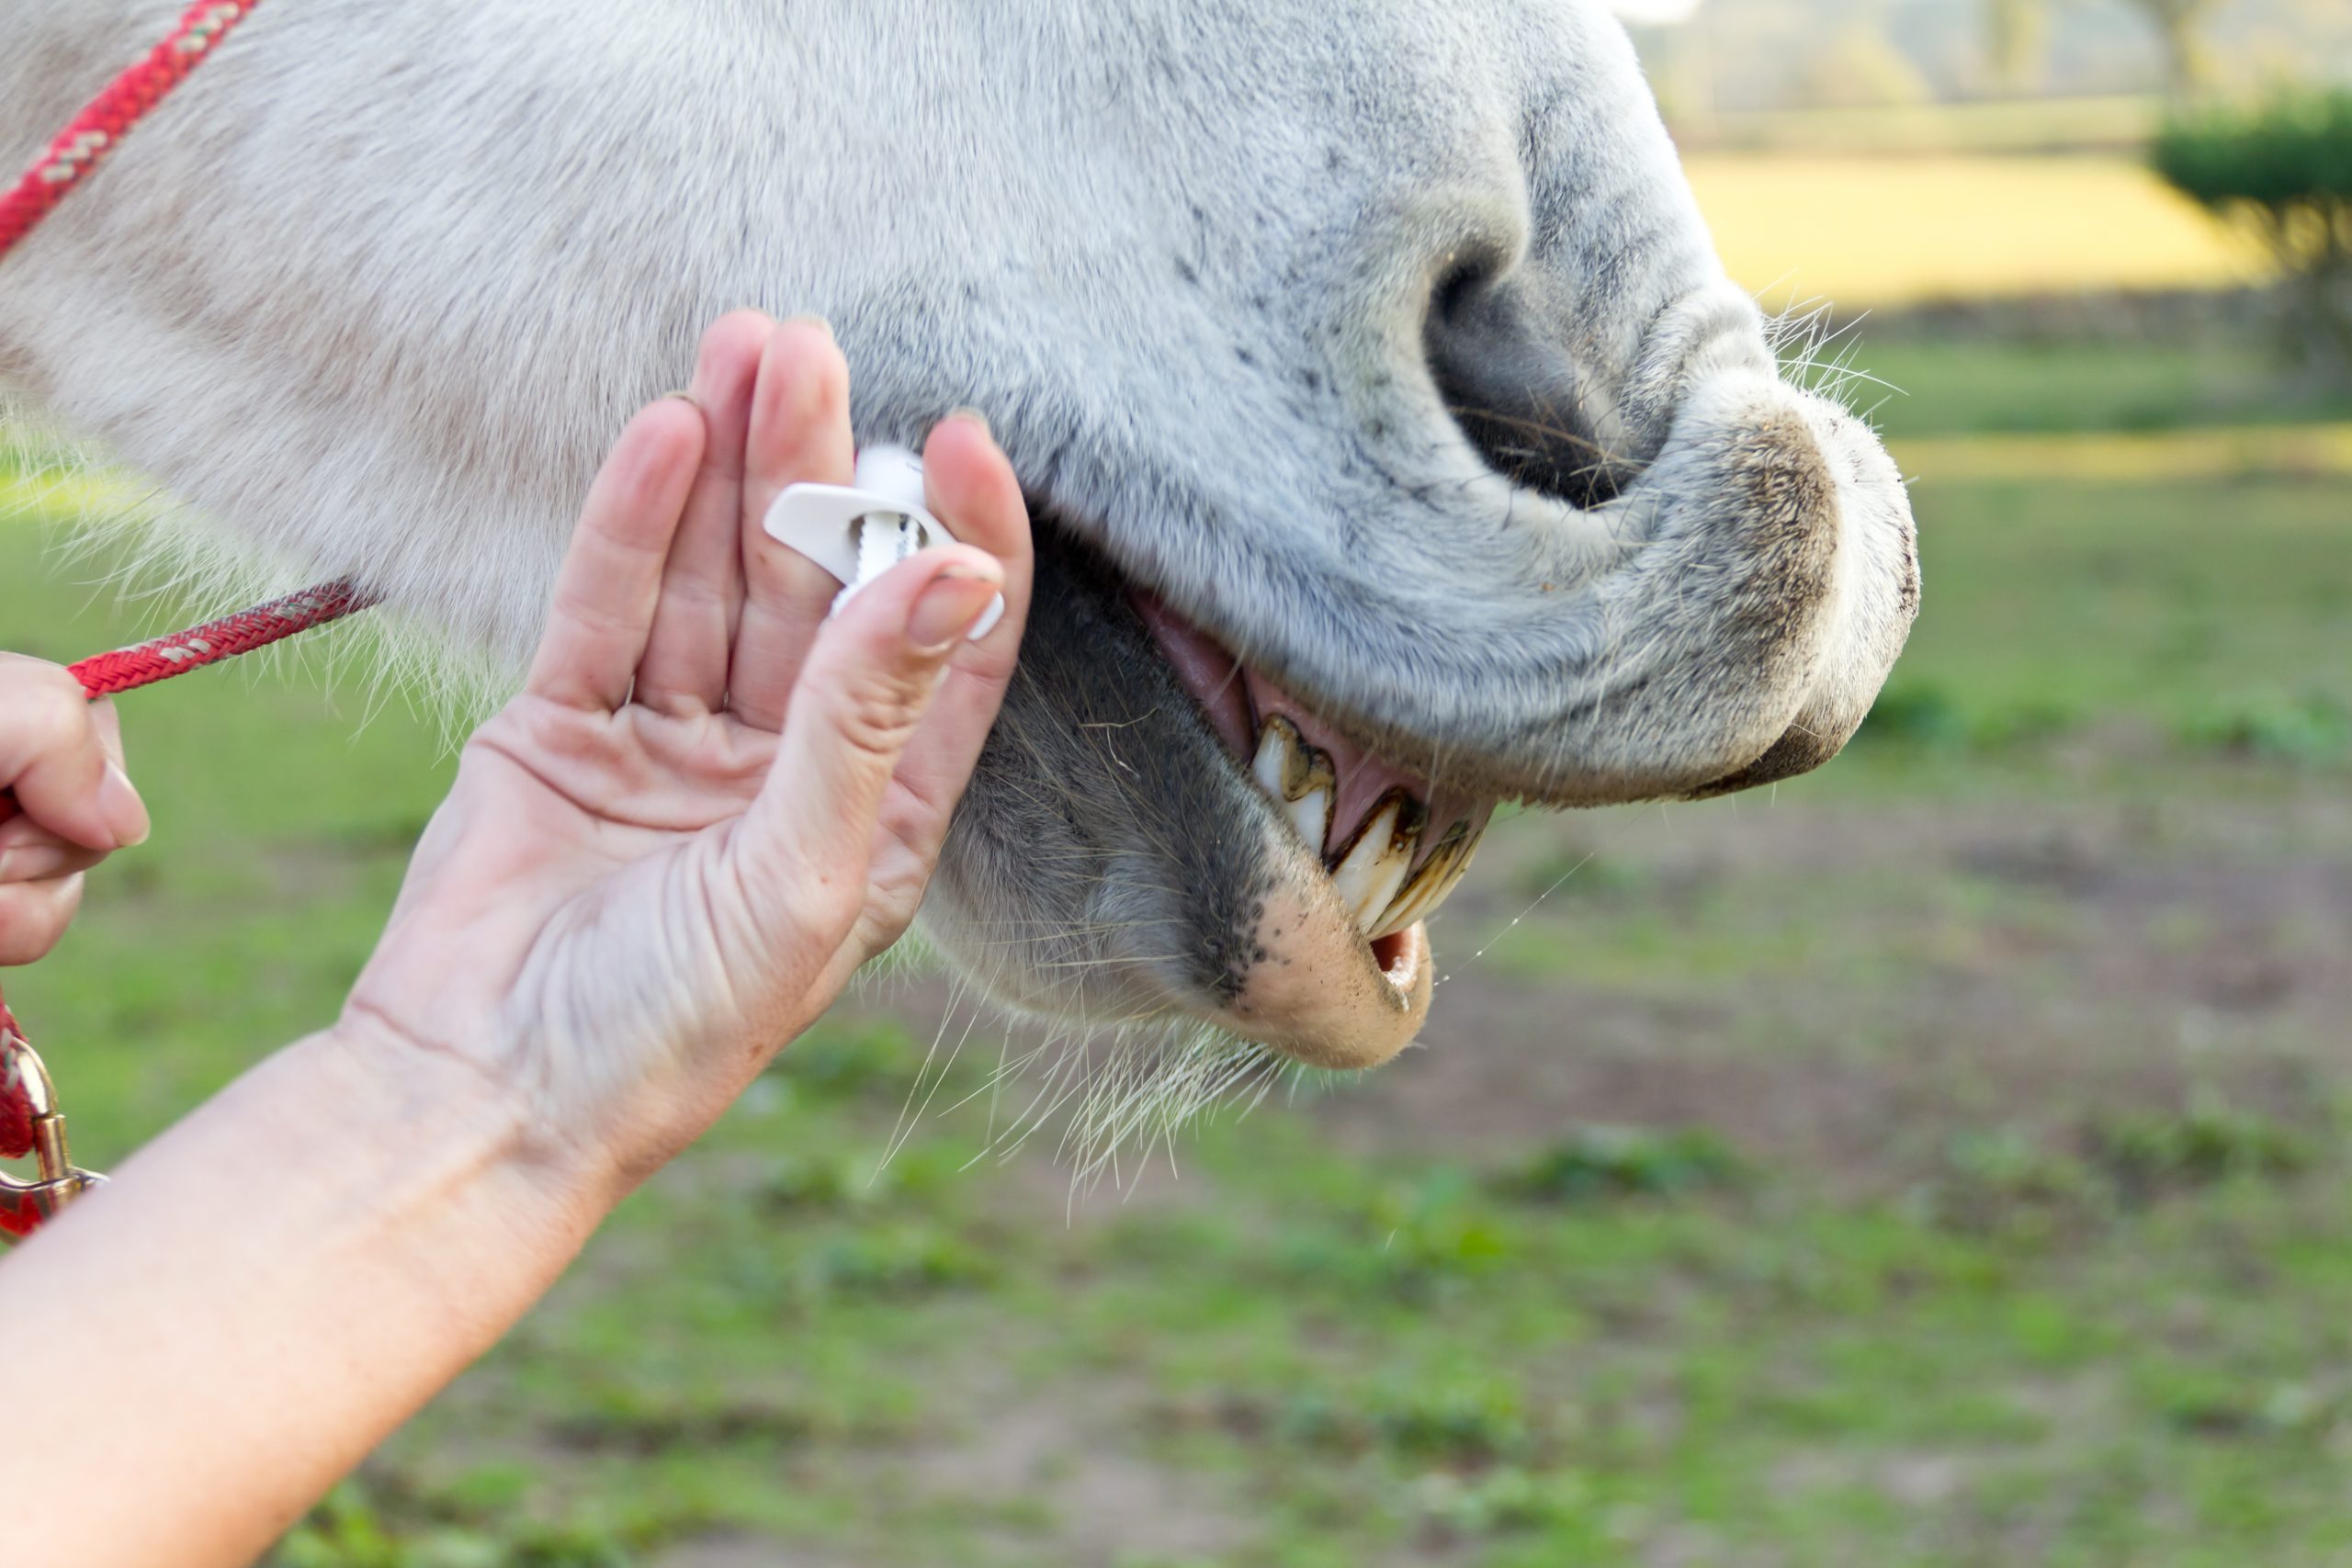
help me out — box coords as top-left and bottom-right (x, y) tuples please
(0, 0), (1919, 1090)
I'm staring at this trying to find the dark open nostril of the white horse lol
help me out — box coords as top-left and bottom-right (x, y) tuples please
(1423, 272), (1633, 508)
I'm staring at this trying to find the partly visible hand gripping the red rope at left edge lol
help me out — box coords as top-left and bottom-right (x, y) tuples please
(0, 653), (148, 966)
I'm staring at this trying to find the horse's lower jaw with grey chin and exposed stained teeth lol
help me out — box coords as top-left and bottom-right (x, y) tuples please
(924, 524), (1491, 1067)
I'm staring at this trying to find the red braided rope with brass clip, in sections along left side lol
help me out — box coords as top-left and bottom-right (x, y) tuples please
(0, 0), (374, 1239)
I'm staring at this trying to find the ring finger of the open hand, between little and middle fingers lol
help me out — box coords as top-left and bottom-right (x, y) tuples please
(638, 310), (776, 712)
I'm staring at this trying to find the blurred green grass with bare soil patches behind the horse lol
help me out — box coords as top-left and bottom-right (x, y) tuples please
(0, 333), (2352, 1568)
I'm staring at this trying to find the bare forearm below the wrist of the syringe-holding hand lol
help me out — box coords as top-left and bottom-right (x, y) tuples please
(0, 1025), (618, 1568)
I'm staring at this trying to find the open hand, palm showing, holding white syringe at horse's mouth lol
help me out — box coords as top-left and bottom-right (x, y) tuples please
(339, 312), (1030, 1187)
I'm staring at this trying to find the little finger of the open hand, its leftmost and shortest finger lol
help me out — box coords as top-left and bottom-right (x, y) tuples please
(525, 398), (703, 710)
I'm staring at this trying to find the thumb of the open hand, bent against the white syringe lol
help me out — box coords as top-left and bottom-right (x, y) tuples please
(739, 546), (1004, 915)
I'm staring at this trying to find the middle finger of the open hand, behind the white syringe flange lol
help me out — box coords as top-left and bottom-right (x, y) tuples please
(727, 317), (856, 728)
